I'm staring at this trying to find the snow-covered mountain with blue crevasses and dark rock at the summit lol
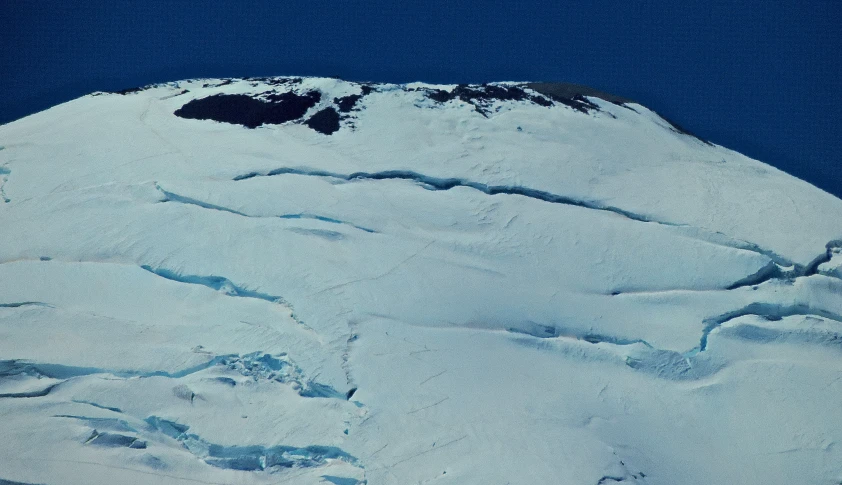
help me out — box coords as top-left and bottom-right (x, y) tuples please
(0, 78), (842, 485)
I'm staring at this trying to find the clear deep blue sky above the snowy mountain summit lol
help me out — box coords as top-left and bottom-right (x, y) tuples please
(0, 0), (842, 197)
